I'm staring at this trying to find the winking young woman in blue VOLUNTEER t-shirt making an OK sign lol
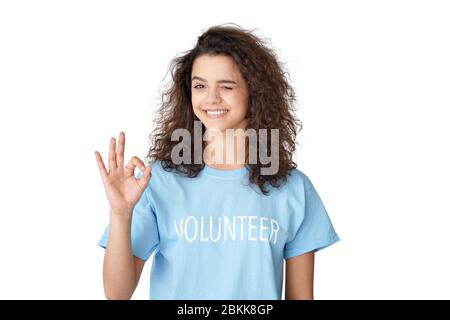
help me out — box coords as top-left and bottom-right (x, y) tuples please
(96, 26), (339, 299)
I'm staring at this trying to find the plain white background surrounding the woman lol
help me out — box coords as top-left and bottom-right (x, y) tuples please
(0, 0), (450, 299)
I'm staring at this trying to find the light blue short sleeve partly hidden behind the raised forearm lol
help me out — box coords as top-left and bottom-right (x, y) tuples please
(98, 172), (159, 260)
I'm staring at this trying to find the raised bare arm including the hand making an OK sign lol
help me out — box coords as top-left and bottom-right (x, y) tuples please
(95, 132), (151, 299)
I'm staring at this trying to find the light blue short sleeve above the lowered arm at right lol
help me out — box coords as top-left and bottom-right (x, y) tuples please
(284, 176), (340, 259)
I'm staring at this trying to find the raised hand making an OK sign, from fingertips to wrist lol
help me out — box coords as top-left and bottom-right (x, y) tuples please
(95, 132), (151, 214)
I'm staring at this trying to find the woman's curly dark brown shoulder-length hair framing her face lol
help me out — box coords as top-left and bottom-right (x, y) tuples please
(145, 24), (302, 195)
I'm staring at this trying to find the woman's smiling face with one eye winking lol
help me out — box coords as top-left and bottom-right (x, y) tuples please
(191, 54), (248, 131)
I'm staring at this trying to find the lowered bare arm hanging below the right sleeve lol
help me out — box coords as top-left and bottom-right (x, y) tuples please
(285, 252), (314, 300)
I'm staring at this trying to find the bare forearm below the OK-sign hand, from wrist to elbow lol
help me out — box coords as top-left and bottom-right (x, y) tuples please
(103, 212), (136, 299)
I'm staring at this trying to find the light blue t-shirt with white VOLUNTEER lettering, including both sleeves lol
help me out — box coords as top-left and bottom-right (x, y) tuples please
(99, 161), (339, 300)
